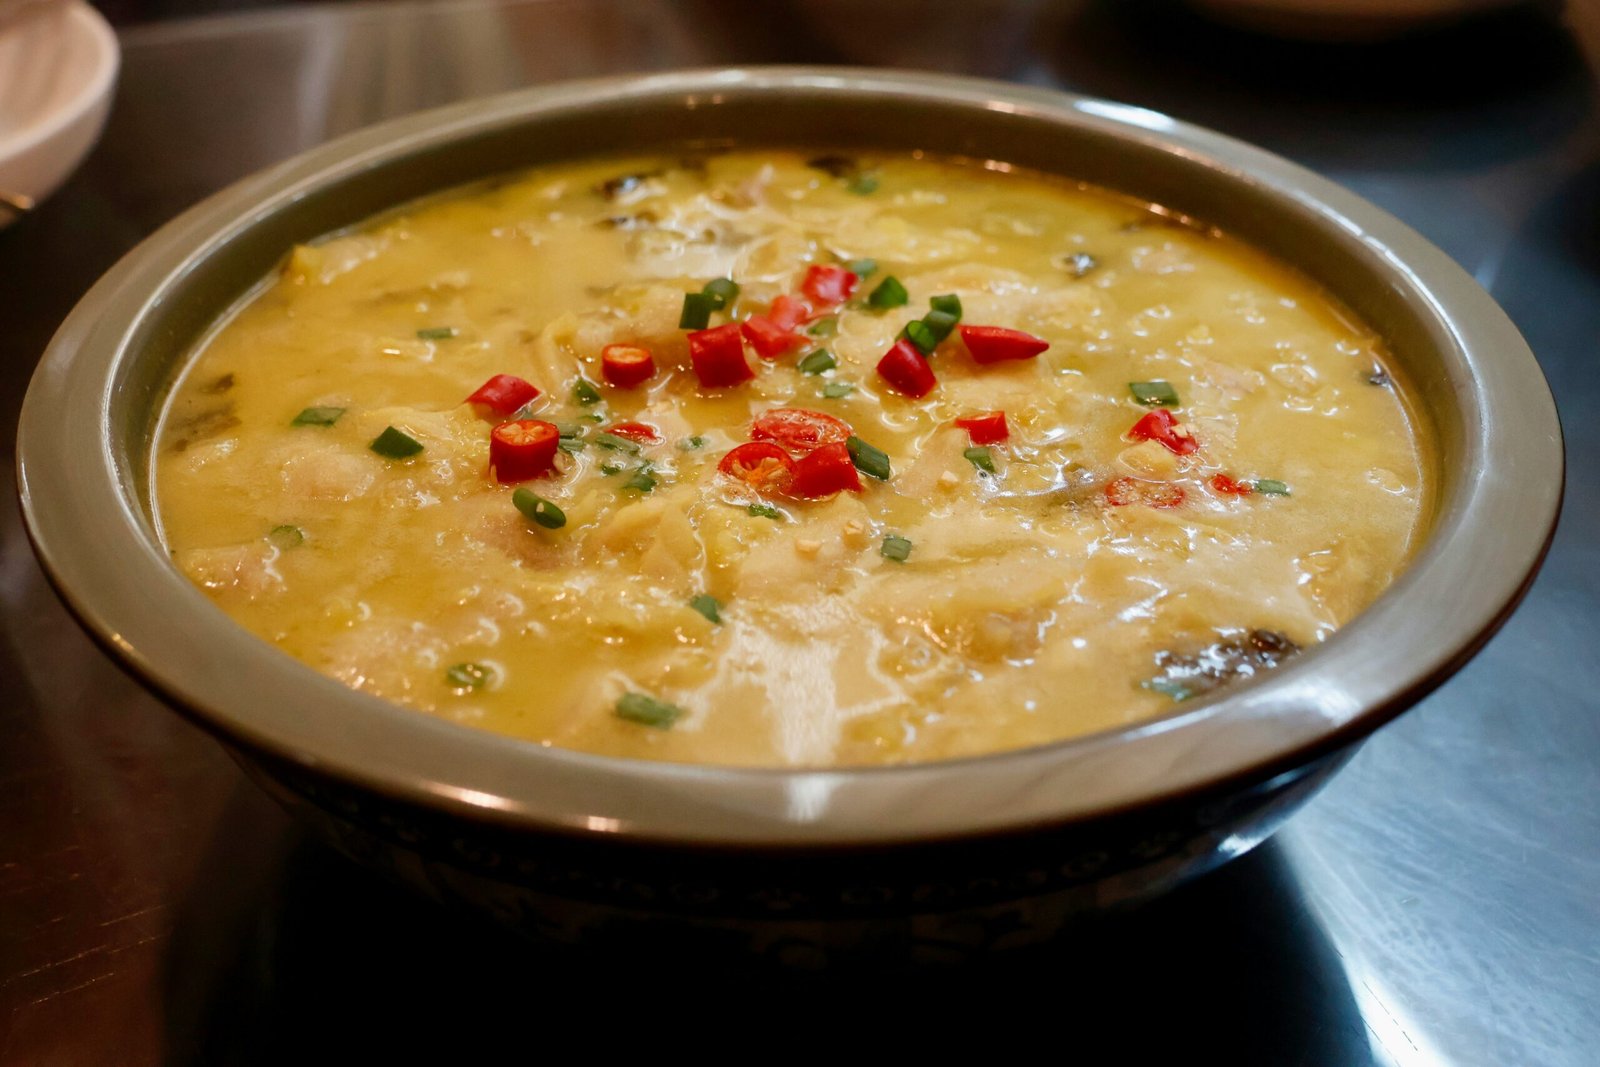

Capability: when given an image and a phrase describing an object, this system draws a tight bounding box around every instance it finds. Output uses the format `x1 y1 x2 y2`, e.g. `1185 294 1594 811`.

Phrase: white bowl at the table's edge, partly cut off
0 0 118 226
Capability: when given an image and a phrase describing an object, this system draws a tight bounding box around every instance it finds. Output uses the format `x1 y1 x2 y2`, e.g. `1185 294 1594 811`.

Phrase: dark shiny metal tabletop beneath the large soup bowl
0 0 1600 1065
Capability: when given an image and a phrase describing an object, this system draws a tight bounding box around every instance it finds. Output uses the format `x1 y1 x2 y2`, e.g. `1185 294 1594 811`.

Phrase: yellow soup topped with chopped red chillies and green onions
155 152 1429 766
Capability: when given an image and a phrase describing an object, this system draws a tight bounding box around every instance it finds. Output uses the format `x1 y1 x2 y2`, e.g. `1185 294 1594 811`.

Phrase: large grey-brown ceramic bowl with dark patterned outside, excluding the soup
18 69 1562 960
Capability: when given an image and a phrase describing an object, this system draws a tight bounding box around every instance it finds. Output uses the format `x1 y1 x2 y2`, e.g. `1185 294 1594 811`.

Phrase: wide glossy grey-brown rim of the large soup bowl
18 67 1565 848
